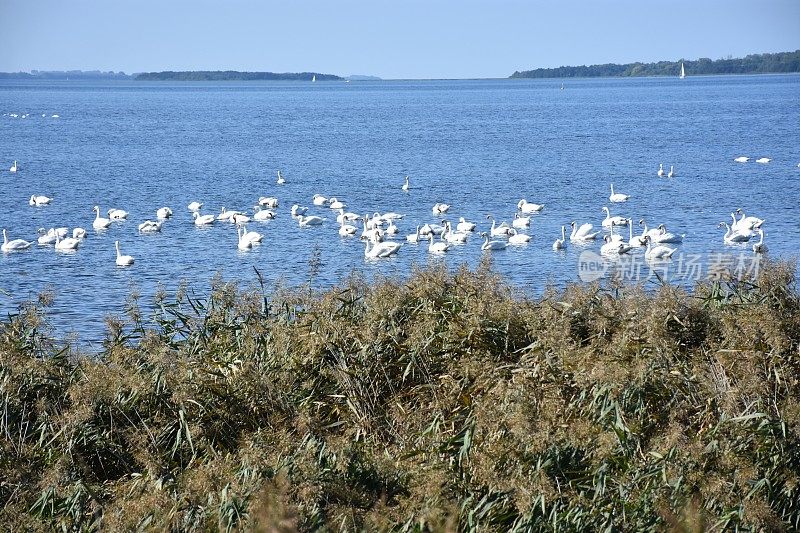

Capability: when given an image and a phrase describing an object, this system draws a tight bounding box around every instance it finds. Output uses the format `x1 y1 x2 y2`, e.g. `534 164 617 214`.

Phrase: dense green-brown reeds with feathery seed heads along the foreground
0 263 800 531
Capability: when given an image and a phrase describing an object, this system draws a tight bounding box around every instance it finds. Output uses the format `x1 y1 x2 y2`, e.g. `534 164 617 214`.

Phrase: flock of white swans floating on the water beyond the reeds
0 161 767 267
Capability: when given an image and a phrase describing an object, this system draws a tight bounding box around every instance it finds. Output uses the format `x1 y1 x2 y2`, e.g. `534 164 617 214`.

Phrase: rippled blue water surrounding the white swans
0 76 800 344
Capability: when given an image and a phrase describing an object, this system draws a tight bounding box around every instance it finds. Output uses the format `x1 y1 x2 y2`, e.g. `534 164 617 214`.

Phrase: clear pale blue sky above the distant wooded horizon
0 0 800 78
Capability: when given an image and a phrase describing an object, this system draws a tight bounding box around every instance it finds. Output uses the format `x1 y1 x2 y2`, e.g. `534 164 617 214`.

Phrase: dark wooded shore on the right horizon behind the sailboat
510 50 800 78
